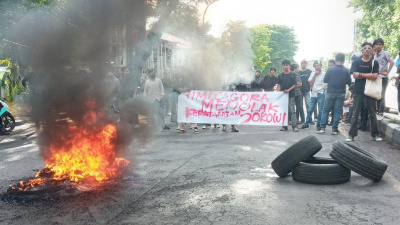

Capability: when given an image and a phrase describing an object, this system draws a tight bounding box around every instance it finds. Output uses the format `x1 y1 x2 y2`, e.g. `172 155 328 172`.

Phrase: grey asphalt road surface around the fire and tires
0 118 400 224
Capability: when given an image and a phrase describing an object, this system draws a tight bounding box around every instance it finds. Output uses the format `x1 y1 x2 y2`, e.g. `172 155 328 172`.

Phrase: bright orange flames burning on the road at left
11 101 129 191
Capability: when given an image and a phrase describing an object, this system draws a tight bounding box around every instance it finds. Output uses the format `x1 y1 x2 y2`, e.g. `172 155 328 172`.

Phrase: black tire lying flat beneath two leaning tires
292 157 351 184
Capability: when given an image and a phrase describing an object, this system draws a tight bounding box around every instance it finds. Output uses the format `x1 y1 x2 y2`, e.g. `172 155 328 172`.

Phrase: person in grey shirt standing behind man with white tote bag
373 38 394 116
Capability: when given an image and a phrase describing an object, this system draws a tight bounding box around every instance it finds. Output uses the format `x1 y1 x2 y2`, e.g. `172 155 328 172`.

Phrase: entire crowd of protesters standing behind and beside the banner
77 38 400 141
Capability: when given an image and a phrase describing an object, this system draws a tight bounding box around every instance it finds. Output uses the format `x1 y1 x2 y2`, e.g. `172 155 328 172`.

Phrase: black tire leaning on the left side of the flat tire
271 135 322 177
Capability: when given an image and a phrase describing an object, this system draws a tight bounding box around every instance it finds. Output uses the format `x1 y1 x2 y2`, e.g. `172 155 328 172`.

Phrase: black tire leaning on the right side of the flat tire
329 141 388 182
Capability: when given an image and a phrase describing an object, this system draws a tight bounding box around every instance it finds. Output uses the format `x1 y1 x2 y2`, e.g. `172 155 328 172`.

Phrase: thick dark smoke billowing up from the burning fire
7 0 156 163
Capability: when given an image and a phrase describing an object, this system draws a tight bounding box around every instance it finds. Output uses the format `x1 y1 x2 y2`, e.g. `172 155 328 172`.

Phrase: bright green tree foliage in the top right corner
349 0 400 55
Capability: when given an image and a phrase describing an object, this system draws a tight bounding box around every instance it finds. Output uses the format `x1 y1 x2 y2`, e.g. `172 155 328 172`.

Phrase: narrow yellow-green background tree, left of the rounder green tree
250 25 272 74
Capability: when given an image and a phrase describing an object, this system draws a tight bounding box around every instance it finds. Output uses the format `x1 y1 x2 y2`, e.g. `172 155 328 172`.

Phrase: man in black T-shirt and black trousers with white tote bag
346 42 382 141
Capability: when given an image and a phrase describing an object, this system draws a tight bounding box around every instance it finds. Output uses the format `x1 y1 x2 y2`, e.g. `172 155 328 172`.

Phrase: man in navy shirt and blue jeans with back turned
318 53 351 135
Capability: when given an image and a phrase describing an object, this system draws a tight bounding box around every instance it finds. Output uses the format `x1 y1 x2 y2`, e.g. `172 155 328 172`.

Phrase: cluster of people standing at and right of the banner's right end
251 38 400 142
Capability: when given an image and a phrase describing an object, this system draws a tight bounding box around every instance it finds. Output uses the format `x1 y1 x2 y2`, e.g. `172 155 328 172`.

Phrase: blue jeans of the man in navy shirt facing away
321 93 346 130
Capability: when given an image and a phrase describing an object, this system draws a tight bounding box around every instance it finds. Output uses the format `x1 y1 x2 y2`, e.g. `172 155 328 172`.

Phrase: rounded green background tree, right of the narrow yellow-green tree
264 25 298 73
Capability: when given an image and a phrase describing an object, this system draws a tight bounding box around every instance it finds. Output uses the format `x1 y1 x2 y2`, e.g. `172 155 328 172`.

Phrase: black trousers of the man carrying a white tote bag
349 93 379 137
